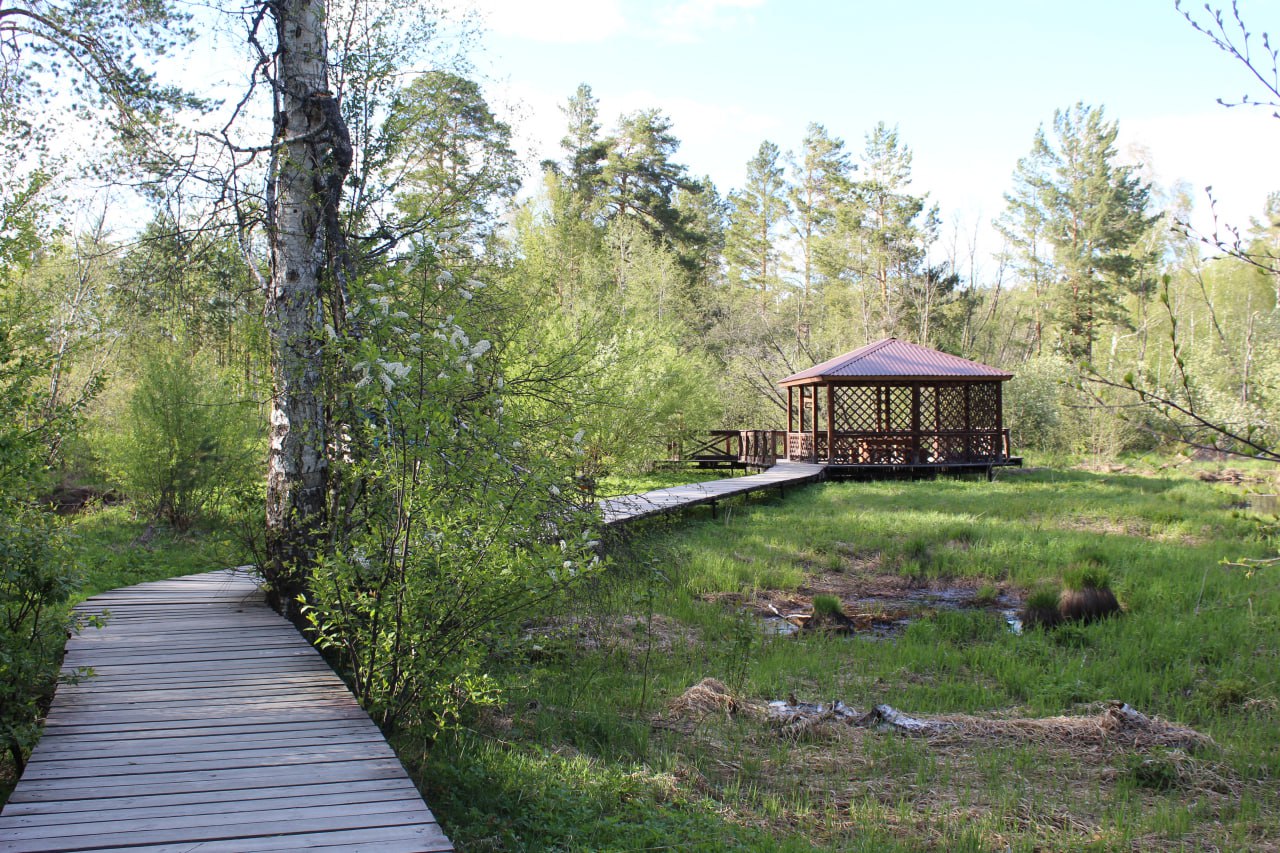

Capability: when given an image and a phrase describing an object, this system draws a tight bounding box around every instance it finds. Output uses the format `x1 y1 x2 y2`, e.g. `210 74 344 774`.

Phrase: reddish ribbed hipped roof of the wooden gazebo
778 338 1014 387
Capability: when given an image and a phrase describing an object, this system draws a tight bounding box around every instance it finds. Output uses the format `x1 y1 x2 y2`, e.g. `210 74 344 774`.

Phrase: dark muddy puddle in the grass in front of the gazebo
748 587 1023 639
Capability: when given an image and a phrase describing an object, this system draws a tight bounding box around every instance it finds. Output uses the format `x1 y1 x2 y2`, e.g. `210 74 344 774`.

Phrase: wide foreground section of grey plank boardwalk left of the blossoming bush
0 570 453 853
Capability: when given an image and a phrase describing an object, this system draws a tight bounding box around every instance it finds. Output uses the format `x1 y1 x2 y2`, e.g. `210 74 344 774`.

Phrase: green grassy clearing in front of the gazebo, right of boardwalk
419 470 1280 850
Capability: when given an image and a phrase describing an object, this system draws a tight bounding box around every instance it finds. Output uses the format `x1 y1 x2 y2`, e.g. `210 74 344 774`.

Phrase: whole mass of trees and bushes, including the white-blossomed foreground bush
0 3 1280 763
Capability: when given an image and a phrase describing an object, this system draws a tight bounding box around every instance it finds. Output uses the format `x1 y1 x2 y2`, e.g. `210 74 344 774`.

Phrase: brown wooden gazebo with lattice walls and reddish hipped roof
780 338 1021 473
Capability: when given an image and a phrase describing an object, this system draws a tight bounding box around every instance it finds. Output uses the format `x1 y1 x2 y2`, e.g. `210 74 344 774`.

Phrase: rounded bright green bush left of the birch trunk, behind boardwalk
101 346 261 529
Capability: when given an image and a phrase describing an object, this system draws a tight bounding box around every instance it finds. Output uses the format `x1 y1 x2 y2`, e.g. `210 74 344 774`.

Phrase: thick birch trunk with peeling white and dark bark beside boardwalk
264 0 352 612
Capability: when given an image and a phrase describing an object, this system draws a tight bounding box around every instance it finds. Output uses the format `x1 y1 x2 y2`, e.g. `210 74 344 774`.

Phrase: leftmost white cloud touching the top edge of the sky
470 0 627 44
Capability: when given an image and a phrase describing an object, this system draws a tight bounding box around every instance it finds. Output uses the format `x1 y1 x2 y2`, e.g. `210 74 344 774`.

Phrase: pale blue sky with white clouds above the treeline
466 0 1280 262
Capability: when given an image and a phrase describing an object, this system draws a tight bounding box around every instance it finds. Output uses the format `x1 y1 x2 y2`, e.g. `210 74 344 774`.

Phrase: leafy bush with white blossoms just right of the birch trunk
300 268 596 736
